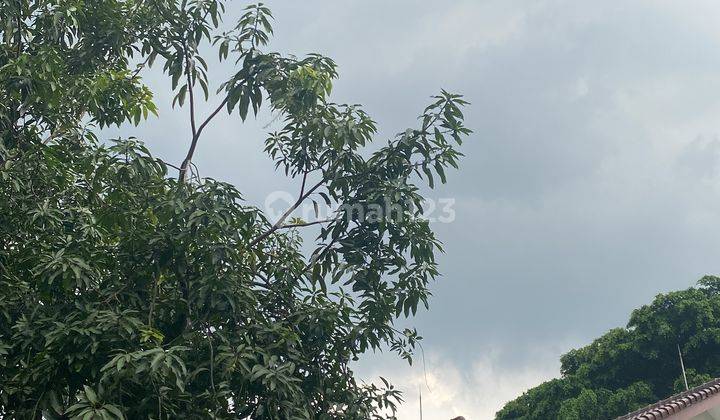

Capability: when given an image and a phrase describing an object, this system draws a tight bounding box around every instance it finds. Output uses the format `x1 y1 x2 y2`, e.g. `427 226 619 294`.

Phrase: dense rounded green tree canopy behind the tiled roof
497 276 720 420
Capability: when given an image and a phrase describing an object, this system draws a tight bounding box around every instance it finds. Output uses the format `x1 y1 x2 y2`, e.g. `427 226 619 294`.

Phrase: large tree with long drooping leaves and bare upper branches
0 0 470 419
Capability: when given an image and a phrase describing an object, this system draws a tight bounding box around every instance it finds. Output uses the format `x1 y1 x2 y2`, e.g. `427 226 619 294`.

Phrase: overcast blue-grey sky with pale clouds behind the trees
108 0 720 420
